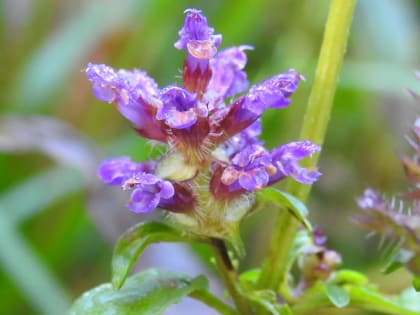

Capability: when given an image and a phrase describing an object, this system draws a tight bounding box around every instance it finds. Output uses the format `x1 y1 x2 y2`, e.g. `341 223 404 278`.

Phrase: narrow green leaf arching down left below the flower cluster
112 222 203 289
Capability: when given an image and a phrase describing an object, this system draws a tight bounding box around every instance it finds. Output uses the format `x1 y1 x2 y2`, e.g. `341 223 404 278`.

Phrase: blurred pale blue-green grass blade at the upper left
12 0 142 112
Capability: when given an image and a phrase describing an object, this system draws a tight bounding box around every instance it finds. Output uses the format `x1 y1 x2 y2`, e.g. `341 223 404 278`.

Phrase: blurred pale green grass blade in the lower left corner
0 208 70 315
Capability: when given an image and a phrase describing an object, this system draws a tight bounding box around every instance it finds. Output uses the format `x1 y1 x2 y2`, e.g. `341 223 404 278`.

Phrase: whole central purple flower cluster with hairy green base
86 9 320 233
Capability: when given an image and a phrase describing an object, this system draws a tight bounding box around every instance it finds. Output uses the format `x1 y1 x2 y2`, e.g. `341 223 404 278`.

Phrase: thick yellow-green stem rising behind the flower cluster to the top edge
259 0 356 298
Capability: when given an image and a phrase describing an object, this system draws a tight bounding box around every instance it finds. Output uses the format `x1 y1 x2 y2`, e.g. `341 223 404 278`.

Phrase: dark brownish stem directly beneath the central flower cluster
211 238 253 315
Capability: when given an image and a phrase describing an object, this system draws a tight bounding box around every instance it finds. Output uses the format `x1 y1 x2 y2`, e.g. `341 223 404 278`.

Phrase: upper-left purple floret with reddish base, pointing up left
85 63 167 141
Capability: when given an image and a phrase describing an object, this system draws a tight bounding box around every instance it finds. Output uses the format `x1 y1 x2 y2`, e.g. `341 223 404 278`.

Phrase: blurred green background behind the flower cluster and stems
0 0 420 314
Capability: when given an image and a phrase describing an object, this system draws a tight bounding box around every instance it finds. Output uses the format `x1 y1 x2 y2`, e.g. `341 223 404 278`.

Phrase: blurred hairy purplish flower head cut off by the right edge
353 82 420 276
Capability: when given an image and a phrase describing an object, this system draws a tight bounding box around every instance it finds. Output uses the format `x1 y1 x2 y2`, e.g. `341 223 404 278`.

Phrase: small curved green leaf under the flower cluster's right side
256 187 312 231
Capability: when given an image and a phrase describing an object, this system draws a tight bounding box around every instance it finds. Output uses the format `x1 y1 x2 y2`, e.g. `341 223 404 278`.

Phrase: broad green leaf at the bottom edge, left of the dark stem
67 269 208 315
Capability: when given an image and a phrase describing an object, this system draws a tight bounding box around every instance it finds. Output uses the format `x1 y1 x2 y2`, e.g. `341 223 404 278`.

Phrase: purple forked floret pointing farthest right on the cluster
270 141 321 184
